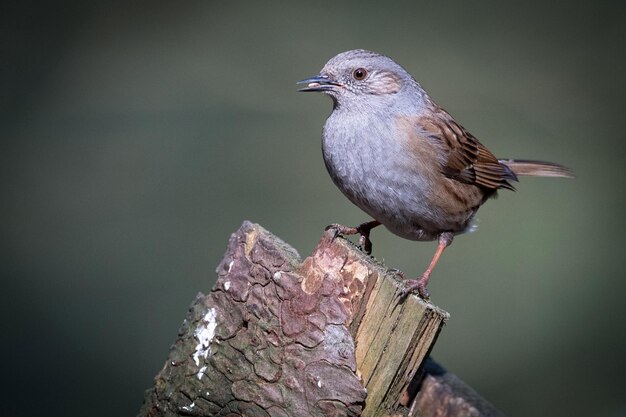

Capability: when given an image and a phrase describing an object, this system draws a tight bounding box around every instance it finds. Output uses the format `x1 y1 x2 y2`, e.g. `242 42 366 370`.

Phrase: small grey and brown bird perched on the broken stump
297 49 574 300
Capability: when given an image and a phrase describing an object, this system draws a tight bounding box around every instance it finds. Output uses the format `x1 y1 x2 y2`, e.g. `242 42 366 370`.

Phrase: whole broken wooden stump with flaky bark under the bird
139 222 501 417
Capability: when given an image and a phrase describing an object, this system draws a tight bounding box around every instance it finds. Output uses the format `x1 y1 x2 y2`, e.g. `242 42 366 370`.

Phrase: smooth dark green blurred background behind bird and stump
0 1 626 416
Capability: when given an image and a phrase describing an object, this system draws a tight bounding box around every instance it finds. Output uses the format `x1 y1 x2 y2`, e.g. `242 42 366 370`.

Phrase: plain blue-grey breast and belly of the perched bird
322 111 435 240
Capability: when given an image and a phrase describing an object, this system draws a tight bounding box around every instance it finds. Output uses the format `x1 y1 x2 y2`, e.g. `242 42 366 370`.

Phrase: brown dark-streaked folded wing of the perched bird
420 108 517 190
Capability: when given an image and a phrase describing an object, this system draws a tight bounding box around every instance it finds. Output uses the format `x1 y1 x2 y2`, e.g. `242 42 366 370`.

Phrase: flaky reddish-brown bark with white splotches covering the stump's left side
140 222 366 416
